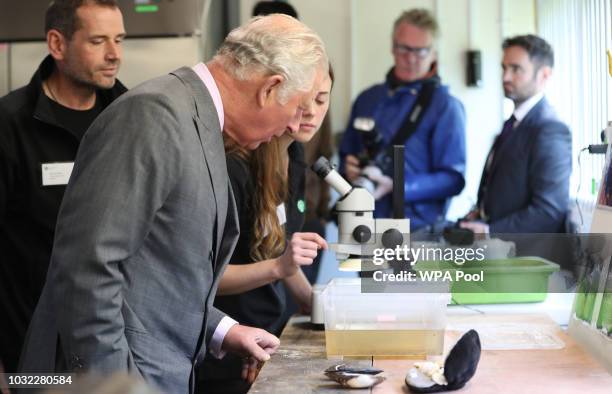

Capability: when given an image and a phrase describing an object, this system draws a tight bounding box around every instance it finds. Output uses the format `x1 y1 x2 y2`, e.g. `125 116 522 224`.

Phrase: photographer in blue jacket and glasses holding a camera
340 9 465 231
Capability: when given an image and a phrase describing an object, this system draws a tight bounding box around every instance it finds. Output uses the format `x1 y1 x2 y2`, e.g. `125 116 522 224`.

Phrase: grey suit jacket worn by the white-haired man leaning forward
21 68 239 393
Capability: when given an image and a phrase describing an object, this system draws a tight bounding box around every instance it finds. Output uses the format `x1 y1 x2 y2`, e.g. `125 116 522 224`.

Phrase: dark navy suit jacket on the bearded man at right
479 98 572 233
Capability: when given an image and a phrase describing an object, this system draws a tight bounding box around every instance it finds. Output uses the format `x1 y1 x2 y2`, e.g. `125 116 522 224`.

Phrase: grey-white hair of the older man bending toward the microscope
215 14 329 104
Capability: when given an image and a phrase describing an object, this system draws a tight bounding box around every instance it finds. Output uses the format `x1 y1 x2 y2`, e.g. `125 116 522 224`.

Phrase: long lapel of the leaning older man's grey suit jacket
172 67 229 268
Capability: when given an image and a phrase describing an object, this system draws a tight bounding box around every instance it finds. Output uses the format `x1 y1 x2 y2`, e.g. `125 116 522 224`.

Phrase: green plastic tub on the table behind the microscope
414 257 559 305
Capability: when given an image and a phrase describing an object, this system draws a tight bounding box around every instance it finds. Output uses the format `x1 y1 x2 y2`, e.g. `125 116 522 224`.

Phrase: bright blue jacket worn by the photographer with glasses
340 76 465 230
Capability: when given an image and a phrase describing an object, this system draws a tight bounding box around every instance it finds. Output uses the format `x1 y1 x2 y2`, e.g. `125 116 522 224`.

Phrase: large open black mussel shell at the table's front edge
406 330 481 393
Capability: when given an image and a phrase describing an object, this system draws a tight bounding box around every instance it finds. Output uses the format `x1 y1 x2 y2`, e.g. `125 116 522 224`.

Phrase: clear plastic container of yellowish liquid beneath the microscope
323 278 450 356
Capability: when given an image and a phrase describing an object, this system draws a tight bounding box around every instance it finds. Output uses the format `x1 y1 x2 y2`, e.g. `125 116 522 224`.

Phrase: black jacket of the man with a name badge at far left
0 56 127 372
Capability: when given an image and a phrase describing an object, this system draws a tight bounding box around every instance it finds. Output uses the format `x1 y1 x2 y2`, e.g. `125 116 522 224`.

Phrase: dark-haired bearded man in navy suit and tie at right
461 35 572 233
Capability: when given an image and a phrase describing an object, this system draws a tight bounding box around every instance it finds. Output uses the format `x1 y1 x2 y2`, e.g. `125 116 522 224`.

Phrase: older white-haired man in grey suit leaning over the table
21 15 328 393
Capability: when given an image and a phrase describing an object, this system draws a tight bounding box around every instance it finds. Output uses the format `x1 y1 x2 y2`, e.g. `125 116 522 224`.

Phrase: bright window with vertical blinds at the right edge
537 0 612 231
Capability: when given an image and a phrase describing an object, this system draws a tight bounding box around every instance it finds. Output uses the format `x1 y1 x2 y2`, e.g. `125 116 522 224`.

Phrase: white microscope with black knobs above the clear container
312 145 410 272
